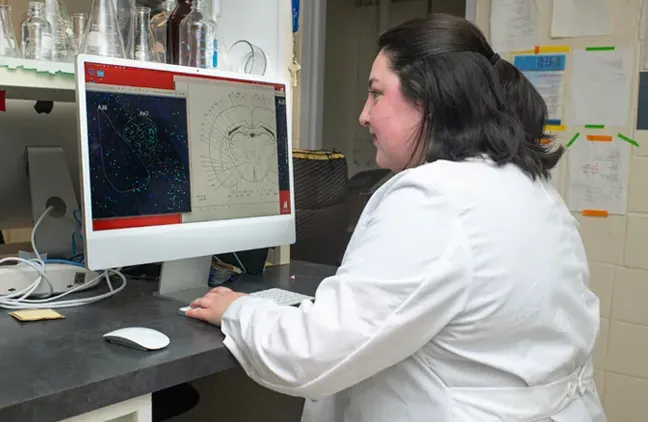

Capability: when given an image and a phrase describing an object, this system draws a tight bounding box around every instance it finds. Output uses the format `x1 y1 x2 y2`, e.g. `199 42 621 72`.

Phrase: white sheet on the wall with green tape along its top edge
567 47 634 127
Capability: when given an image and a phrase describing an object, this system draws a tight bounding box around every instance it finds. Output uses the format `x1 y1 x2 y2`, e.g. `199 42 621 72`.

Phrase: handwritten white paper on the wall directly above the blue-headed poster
490 0 539 53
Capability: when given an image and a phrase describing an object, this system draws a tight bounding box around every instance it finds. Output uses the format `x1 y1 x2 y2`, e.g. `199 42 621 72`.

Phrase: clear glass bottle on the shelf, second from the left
22 1 52 61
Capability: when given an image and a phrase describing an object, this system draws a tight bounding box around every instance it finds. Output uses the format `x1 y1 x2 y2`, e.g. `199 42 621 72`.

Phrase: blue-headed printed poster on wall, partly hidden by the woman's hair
513 54 567 126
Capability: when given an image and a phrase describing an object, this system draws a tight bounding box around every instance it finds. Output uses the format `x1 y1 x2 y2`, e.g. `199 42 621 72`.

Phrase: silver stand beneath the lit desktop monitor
156 256 212 304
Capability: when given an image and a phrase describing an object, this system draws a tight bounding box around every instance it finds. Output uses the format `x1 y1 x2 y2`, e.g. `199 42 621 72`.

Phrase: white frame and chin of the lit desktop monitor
76 55 296 287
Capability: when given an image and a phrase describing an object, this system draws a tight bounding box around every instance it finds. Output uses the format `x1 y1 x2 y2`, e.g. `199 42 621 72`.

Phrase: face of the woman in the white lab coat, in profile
359 52 422 171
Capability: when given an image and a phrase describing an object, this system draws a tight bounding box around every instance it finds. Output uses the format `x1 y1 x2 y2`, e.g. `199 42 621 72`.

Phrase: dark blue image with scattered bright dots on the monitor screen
86 91 191 219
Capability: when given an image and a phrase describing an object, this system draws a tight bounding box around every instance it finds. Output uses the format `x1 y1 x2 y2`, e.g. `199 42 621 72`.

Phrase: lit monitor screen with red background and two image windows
84 62 291 231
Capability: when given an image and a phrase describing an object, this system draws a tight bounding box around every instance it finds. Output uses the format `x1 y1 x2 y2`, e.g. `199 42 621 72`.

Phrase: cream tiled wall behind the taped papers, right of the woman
477 0 648 422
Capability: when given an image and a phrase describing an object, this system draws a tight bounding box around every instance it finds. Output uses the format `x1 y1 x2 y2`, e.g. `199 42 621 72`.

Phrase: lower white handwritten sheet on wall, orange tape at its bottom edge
567 136 630 214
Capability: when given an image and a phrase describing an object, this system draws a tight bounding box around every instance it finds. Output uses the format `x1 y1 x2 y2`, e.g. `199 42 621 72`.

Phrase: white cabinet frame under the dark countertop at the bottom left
60 394 153 422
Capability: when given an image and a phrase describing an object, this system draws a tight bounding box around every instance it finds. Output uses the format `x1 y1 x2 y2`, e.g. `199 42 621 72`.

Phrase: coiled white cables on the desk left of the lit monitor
0 207 126 309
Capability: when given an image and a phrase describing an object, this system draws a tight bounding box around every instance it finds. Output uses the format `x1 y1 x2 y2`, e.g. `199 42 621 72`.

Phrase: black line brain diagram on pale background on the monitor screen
184 77 279 210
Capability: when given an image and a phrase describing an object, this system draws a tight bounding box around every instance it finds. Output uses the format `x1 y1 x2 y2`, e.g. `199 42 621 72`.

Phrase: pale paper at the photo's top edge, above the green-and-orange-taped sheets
551 0 612 38
